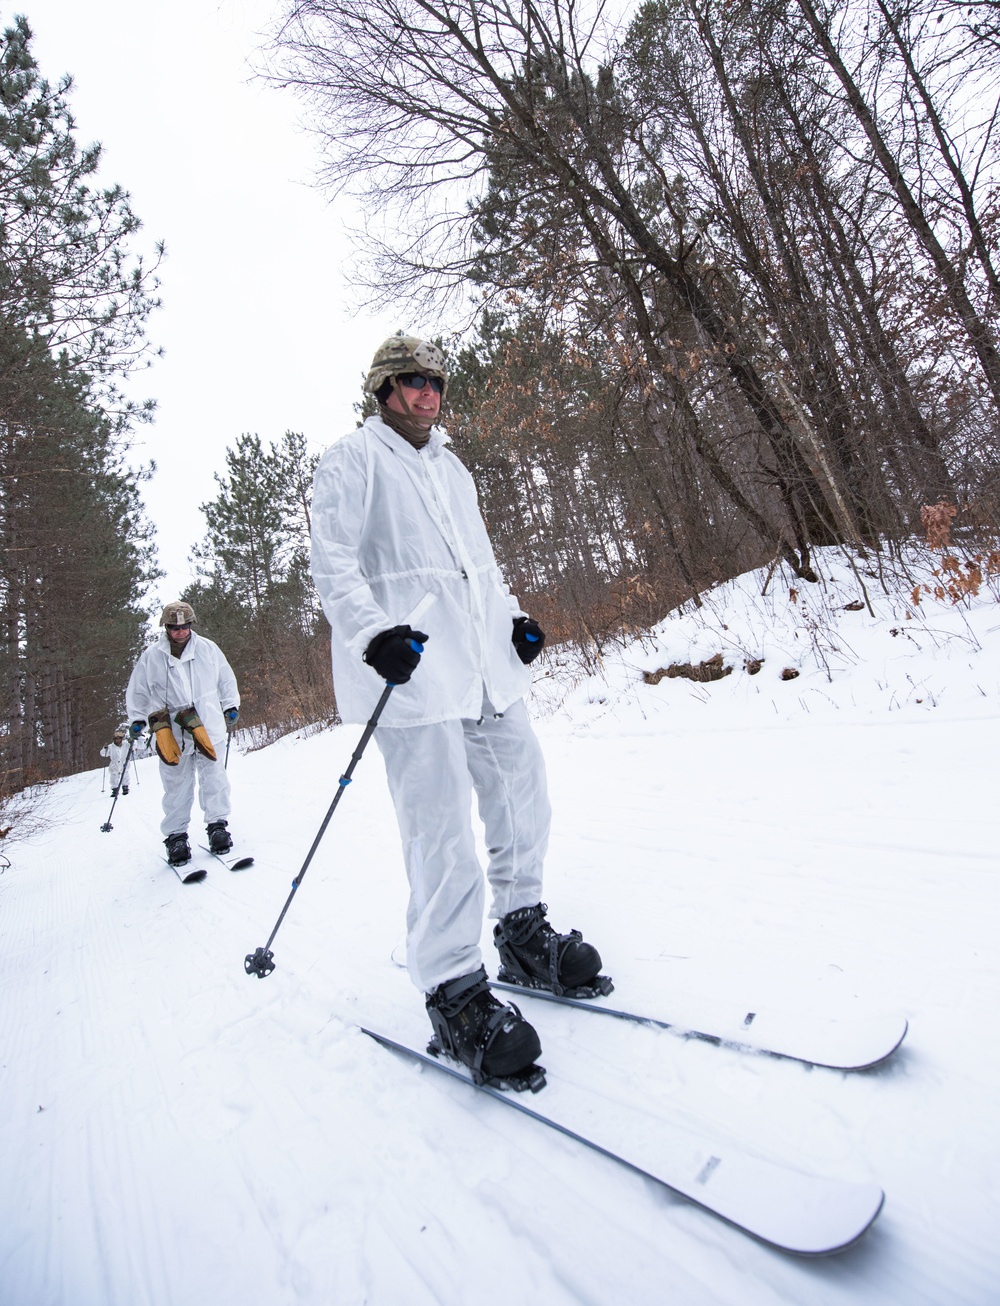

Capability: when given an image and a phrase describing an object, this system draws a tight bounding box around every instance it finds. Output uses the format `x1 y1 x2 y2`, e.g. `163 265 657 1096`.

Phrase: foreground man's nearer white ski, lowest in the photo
363 1029 885 1256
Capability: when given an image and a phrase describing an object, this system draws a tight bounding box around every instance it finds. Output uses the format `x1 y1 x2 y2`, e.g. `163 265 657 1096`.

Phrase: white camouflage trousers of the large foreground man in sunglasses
375 700 551 993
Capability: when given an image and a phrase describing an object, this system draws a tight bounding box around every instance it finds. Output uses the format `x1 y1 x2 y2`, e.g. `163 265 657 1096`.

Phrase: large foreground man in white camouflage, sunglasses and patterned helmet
312 336 611 1083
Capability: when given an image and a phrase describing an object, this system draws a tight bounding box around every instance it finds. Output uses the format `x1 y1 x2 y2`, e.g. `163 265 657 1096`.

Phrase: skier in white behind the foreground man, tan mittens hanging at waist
125 602 240 866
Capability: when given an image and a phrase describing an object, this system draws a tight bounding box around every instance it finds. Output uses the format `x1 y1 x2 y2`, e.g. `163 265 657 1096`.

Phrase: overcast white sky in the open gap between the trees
21 0 412 606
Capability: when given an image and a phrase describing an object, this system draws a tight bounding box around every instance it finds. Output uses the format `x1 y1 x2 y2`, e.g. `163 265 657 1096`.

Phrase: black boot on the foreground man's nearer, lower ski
426 966 546 1093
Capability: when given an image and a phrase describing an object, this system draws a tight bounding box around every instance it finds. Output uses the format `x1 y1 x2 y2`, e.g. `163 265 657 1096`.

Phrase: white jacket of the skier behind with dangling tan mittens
125 631 240 752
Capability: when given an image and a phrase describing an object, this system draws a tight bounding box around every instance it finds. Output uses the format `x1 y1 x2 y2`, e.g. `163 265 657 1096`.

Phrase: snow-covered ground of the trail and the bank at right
0 545 1000 1306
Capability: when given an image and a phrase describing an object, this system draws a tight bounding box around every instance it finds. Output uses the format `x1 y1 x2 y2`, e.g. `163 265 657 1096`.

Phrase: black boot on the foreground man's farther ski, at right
493 902 615 998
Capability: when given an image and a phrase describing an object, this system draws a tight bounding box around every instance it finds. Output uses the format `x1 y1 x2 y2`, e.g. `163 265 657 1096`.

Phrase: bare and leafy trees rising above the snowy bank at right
272 0 1000 643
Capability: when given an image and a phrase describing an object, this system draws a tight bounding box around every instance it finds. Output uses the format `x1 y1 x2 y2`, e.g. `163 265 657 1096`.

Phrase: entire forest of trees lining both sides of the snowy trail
0 0 1000 820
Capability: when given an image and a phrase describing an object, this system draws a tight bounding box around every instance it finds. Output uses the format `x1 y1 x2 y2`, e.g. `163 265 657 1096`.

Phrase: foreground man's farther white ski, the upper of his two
490 980 907 1070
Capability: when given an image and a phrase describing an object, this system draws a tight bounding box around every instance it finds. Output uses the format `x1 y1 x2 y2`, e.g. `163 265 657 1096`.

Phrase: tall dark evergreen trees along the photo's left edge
0 17 157 804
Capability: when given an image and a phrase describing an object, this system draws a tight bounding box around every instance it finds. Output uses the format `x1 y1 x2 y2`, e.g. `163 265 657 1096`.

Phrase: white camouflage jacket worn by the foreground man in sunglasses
312 417 531 726
